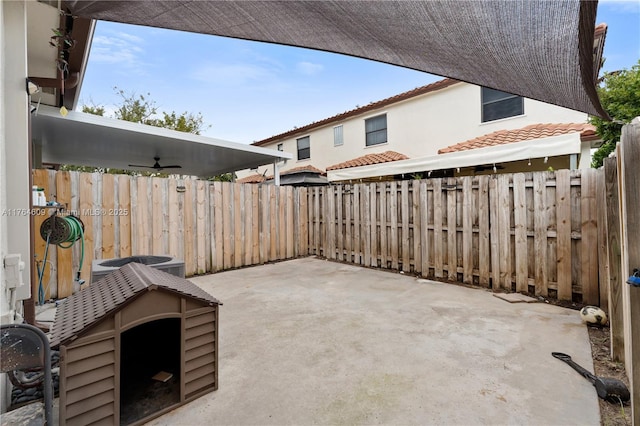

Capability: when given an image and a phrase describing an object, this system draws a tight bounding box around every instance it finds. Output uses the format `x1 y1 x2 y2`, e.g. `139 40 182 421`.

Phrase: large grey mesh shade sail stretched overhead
64 0 607 117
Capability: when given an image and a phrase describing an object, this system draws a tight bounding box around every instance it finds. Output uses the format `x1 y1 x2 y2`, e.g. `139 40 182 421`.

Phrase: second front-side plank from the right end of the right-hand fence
556 170 572 300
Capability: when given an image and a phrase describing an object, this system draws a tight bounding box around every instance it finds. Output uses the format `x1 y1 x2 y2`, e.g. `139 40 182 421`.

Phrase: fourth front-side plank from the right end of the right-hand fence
513 173 529 292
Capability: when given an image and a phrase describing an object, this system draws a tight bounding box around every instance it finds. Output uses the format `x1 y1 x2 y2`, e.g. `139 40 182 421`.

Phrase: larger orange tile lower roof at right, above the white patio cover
438 123 596 154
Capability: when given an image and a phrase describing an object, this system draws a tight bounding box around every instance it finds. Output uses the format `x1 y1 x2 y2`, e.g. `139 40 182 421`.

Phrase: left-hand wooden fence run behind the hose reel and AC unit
33 170 307 299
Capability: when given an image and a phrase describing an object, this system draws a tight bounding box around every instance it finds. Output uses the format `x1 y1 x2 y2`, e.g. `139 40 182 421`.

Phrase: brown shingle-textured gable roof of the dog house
51 263 222 346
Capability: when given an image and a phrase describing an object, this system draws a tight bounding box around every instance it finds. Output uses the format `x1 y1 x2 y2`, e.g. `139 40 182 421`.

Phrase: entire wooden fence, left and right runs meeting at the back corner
34 170 607 306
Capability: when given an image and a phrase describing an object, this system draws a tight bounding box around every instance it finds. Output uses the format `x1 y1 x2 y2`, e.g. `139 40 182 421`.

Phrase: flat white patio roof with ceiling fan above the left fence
32 105 292 176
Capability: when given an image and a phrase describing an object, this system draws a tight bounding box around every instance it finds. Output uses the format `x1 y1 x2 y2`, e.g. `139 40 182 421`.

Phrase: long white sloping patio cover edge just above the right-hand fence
327 132 582 182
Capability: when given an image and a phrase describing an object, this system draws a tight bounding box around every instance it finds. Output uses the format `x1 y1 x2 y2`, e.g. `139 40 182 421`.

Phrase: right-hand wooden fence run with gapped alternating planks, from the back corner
308 170 606 306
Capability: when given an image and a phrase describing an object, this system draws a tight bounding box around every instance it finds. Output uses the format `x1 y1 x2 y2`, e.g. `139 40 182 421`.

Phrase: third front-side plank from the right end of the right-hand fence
533 173 548 297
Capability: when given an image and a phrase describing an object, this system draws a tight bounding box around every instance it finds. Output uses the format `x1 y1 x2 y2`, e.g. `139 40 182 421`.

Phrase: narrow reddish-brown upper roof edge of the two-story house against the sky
251 78 460 146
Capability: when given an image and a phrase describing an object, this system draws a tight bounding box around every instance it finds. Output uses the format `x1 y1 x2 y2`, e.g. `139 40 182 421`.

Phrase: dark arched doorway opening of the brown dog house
120 318 181 425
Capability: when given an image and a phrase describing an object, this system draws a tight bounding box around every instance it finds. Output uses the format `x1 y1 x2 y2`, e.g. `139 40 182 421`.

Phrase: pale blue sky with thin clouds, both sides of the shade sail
80 0 640 143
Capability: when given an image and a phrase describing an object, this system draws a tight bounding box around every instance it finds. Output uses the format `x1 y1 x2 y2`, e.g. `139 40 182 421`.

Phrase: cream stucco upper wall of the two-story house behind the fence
238 83 587 177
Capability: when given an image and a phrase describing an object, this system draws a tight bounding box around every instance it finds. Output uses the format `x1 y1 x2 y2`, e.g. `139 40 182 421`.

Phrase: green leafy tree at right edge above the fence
589 60 640 168
